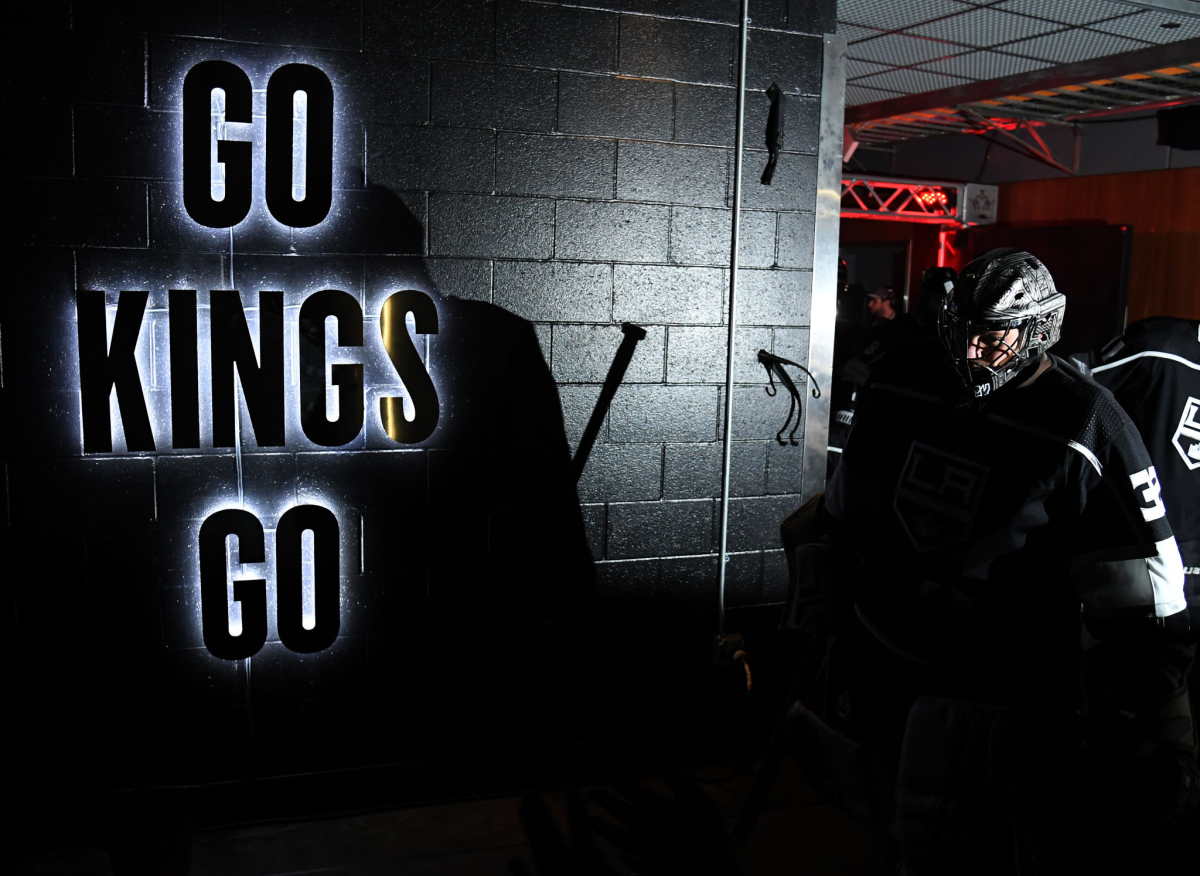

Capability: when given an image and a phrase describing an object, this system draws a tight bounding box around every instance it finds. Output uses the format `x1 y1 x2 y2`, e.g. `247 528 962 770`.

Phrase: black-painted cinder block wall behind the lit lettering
0 0 835 799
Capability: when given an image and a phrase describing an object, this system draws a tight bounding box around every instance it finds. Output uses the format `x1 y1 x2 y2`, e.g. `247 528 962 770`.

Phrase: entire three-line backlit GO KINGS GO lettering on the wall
77 60 439 660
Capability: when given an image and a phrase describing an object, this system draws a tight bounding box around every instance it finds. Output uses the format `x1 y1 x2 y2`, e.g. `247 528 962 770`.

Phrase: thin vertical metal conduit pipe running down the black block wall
716 0 750 641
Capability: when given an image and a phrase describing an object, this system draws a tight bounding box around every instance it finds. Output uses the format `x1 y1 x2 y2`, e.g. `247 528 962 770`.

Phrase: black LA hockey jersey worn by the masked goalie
826 341 1186 664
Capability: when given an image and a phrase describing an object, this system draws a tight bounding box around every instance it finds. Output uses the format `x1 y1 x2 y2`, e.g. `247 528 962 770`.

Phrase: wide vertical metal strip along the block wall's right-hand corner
800 34 846 502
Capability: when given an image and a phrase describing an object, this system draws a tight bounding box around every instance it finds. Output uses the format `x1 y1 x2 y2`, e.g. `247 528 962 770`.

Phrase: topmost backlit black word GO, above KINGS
184 61 334 228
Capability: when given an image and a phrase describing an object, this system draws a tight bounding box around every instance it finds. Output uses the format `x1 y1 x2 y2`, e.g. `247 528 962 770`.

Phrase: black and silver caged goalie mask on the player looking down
937 248 1067 401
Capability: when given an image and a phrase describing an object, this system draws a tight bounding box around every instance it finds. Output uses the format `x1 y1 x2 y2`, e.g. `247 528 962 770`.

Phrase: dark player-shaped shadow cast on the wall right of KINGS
338 186 594 622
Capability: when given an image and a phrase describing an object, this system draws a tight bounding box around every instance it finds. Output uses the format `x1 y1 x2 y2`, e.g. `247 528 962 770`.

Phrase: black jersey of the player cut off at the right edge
1092 317 1200 626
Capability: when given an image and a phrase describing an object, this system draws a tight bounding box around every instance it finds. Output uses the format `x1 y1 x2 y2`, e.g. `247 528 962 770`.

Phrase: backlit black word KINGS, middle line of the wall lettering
76 289 440 454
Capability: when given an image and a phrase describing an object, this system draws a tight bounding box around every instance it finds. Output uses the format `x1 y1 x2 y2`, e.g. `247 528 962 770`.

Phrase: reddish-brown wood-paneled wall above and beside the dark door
998 168 1200 323
